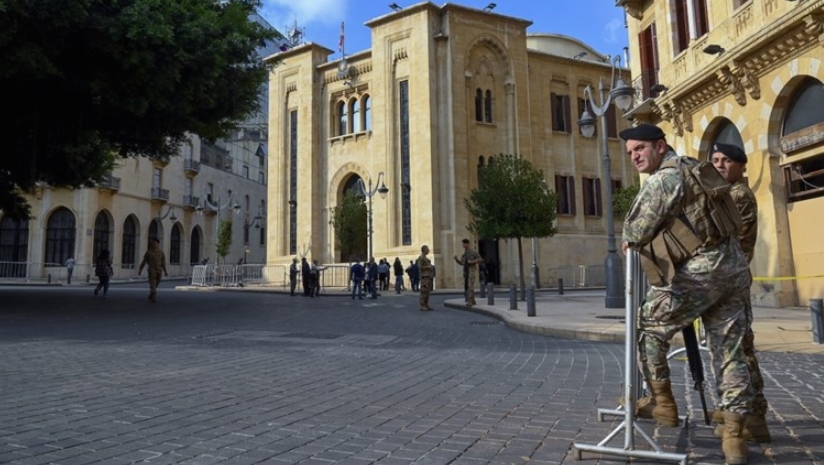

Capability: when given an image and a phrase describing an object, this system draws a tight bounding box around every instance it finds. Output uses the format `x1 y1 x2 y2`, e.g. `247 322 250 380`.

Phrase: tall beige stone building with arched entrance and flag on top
267 2 636 287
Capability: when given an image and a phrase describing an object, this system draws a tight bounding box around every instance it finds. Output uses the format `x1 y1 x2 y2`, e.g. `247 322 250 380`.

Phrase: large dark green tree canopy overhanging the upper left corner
0 0 280 218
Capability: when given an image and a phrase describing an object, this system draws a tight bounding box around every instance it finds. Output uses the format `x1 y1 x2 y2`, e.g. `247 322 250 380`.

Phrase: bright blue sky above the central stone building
261 0 628 58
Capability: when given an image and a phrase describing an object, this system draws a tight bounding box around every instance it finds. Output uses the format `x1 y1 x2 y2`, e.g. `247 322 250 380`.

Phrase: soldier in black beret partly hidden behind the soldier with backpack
711 143 772 442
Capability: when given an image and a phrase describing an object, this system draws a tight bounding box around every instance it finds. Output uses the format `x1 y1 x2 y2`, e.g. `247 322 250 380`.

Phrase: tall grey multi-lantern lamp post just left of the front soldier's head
578 55 635 308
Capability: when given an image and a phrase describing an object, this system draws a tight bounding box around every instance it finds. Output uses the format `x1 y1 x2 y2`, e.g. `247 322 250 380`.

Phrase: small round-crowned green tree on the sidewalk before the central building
464 155 557 296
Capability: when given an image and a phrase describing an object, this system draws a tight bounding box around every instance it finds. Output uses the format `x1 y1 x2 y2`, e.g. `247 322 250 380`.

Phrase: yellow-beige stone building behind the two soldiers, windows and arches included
617 0 824 306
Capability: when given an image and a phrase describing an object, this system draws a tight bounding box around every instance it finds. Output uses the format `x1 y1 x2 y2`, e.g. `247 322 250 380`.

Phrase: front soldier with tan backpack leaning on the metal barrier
620 124 754 464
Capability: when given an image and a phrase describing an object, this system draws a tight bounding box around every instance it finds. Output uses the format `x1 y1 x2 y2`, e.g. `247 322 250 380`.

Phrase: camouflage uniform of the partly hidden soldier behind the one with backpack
730 179 767 416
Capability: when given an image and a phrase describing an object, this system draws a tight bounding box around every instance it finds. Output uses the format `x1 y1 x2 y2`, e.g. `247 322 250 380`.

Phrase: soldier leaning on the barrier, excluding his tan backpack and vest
620 124 753 465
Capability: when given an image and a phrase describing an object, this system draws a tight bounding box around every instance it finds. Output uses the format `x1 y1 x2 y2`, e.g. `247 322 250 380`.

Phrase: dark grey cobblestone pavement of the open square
0 285 824 465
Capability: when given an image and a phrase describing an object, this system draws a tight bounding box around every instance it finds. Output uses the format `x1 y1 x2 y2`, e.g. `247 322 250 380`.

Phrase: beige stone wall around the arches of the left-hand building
9 133 266 278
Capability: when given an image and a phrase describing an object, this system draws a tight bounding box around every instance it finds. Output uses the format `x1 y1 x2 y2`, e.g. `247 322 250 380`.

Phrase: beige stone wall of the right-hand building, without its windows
622 0 824 306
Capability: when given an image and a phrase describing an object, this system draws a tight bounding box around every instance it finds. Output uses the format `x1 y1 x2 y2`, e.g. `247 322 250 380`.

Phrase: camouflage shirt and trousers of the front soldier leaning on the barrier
624 151 753 415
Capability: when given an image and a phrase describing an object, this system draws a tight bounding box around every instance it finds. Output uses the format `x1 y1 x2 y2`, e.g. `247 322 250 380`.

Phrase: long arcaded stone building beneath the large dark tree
0 131 267 280
